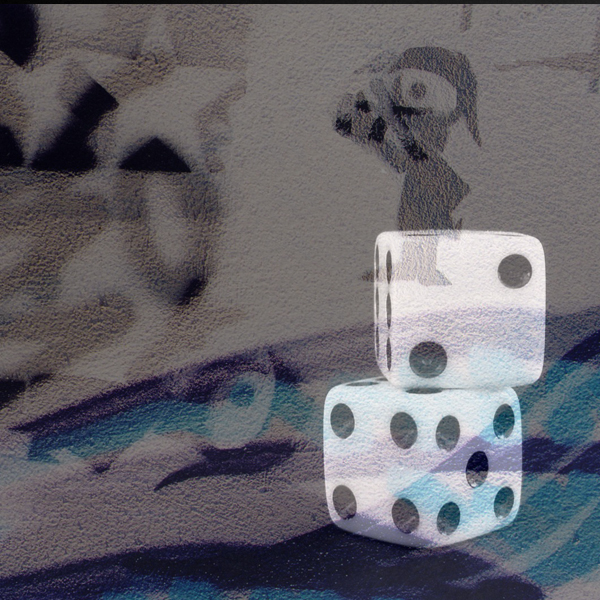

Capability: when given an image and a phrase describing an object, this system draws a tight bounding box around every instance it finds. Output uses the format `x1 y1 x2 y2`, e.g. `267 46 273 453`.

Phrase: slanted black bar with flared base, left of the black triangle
31 82 118 172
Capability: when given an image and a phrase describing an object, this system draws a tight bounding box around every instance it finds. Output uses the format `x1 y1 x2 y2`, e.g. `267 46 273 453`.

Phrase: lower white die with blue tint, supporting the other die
324 377 522 546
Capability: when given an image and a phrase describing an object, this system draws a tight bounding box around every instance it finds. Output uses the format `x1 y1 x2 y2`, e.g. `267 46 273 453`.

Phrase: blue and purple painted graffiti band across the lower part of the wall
0 313 600 599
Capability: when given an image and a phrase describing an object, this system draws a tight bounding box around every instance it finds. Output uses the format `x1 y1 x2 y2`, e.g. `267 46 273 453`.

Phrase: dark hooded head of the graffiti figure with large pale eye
375 46 481 150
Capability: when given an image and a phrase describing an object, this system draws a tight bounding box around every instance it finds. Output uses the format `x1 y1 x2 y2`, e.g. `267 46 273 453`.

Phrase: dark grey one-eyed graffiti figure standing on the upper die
335 47 481 285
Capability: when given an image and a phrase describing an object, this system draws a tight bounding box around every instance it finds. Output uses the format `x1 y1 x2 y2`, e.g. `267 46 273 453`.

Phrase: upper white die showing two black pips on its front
375 231 546 388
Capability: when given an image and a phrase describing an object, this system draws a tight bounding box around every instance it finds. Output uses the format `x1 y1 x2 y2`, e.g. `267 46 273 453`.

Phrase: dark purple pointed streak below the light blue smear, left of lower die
154 441 296 492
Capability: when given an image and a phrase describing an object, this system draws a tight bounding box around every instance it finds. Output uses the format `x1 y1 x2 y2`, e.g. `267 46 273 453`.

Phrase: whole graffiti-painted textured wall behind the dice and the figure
0 5 600 600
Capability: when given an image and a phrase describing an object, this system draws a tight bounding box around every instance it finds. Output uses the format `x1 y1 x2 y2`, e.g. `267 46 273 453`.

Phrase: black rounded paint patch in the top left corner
0 4 38 67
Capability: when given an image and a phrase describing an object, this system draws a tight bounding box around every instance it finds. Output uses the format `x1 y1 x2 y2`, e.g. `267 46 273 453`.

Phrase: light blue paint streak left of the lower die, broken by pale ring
29 383 322 462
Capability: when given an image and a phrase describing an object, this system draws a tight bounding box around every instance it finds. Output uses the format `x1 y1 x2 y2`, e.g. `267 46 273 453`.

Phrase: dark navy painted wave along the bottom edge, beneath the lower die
1 525 543 600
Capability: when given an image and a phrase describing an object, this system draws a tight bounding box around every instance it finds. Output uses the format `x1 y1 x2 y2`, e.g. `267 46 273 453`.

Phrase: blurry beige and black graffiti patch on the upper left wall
0 5 244 406
